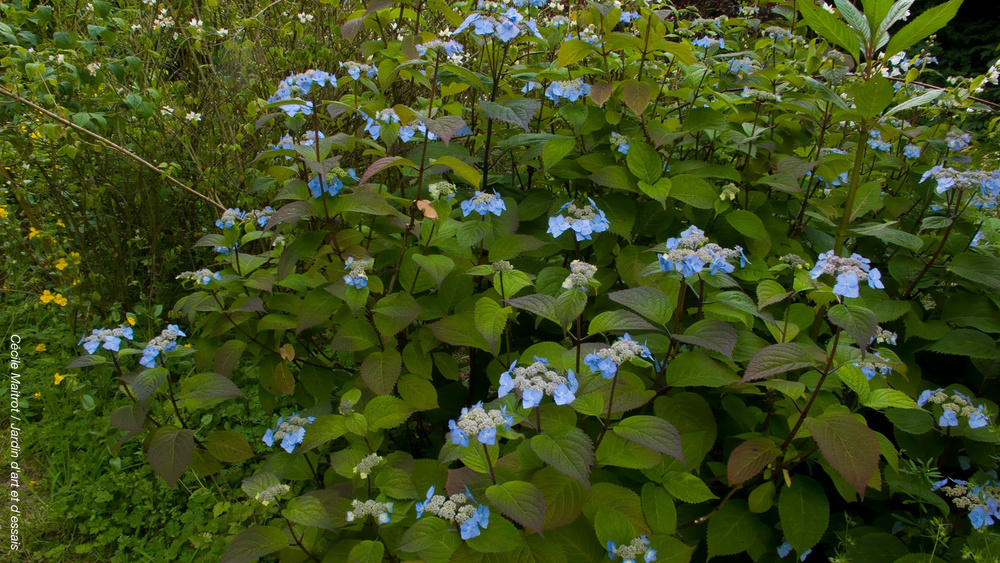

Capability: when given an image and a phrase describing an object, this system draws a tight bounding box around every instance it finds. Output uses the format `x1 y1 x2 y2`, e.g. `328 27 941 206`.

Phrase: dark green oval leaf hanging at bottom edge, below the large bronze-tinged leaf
778 475 830 555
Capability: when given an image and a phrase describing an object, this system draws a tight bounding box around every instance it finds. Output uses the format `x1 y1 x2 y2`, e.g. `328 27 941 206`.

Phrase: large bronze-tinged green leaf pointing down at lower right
805 412 879 500
